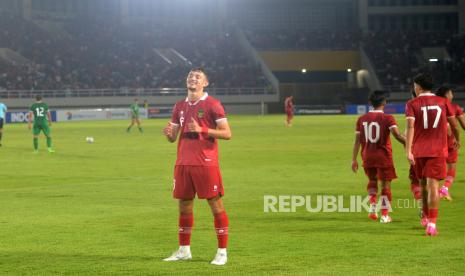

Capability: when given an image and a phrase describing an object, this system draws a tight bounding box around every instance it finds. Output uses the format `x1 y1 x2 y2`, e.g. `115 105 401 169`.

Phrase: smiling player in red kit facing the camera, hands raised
163 68 231 265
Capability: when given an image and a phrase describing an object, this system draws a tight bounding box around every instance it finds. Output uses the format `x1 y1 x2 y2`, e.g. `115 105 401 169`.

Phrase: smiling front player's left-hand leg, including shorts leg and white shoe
164 166 195 261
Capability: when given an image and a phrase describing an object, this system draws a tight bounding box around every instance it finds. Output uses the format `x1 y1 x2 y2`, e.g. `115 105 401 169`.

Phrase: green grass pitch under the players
0 116 465 275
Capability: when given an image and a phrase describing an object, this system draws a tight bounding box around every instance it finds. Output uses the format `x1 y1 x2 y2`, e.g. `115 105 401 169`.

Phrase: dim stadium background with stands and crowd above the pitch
0 0 465 114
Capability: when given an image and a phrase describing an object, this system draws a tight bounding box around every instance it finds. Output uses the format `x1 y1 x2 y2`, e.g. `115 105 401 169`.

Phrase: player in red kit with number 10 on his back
352 91 405 223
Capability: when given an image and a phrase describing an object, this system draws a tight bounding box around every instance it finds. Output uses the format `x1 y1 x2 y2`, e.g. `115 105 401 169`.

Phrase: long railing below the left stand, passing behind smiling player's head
0 87 275 99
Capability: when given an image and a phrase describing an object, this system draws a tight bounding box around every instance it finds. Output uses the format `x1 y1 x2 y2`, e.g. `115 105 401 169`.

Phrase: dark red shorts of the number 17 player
415 157 447 180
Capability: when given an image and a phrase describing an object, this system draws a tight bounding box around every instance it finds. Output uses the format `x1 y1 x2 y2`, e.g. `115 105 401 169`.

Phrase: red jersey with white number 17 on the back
405 93 455 158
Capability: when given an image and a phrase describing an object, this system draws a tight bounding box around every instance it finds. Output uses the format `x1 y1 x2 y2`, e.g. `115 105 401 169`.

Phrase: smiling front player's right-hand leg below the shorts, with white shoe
208 195 229 265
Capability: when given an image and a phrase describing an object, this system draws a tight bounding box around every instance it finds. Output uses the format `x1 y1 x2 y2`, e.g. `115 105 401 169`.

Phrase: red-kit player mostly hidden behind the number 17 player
436 86 465 200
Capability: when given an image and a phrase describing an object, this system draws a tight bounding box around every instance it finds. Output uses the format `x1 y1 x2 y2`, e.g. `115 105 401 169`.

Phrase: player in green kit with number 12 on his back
28 95 55 153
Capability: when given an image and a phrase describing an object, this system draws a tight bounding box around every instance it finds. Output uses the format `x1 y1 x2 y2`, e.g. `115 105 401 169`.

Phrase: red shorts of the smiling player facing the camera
173 166 224 199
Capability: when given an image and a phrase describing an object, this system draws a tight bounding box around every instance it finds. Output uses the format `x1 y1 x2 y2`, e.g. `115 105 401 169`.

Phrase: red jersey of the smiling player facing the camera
171 93 226 167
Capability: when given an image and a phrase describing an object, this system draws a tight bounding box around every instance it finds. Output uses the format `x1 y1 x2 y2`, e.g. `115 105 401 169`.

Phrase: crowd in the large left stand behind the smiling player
0 14 266 90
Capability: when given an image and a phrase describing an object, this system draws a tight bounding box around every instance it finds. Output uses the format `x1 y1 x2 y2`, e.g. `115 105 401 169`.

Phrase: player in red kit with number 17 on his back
405 74 460 236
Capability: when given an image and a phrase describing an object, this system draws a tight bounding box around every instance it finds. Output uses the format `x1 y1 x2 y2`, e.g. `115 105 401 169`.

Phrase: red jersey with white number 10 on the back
355 110 397 168
